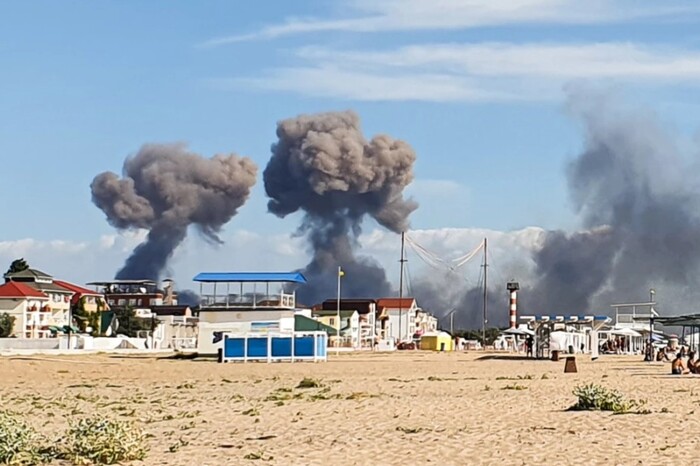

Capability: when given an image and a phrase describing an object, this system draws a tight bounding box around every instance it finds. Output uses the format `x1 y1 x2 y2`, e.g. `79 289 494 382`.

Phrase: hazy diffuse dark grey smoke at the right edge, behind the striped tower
523 87 700 312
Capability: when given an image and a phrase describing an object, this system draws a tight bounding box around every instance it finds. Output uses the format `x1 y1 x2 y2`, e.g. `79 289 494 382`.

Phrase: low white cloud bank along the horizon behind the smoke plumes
0 228 542 289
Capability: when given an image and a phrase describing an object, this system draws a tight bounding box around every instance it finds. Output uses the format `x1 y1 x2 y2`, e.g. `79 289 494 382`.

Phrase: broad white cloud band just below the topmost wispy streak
230 43 700 102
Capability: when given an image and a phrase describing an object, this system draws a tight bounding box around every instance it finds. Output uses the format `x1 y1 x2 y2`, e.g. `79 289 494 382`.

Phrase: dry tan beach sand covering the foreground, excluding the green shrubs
0 351 700 465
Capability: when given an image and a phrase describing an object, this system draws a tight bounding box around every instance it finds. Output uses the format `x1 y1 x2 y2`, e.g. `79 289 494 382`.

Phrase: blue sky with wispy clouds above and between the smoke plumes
0 0 700 288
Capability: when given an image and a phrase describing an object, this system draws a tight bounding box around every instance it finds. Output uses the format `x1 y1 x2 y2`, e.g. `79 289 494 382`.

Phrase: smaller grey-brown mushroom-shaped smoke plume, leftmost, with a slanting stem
90 144 257 280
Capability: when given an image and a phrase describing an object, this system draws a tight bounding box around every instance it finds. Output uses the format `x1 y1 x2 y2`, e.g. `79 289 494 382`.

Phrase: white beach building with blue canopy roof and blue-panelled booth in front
193 272 335 362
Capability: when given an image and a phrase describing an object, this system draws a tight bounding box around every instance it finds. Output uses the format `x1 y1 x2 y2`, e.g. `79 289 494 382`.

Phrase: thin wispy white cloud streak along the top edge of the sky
203 0 700 47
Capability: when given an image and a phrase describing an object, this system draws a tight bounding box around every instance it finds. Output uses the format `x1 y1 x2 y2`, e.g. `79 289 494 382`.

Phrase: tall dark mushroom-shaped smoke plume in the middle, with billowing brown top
263 111 418 304
